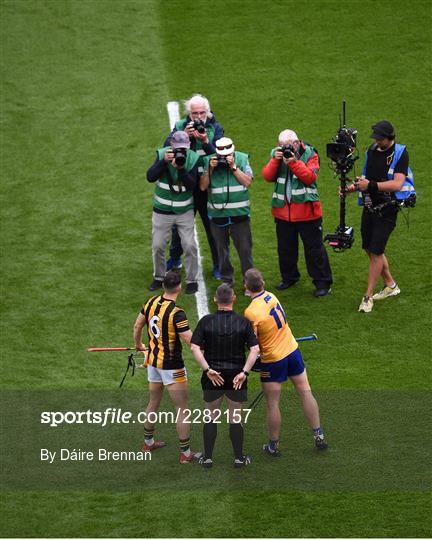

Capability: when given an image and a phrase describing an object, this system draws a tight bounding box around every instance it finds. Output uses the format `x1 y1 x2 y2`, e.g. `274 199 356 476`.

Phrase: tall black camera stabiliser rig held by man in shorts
324 100 358 252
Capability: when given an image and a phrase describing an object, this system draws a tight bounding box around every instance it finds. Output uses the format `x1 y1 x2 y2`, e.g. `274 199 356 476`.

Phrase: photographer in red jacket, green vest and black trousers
262 129 333 298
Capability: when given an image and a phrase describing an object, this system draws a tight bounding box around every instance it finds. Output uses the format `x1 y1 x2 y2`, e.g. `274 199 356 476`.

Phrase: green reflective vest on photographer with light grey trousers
153 147 199 214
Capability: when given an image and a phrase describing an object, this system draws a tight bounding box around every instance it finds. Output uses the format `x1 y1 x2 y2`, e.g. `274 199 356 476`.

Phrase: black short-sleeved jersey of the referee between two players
191 310 258 370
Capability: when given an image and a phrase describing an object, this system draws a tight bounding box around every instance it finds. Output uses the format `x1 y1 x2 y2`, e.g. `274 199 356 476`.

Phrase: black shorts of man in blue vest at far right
361 210 397 255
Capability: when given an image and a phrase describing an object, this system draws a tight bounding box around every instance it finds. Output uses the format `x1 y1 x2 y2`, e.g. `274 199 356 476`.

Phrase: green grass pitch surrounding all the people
0 0 431 537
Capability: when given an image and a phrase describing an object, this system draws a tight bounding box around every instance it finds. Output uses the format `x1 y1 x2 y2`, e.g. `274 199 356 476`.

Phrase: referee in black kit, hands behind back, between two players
191 283 259 468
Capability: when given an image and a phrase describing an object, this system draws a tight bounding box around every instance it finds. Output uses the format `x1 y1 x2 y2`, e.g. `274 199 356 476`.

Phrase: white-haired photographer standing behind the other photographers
165 94 223 279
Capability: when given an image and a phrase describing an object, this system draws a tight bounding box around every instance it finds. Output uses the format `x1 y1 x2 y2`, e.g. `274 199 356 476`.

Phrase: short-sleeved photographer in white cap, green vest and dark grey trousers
200 137 253 285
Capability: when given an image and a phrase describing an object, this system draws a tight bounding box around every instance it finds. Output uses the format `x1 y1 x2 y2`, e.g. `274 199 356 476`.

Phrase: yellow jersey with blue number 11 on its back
244 291 298 362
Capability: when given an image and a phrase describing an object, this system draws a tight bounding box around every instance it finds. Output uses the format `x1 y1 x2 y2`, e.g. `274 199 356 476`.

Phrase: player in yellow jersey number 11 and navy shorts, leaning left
244 268 327 457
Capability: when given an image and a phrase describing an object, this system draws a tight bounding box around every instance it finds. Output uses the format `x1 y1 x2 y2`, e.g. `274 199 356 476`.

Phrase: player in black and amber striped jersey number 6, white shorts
133 272 201 463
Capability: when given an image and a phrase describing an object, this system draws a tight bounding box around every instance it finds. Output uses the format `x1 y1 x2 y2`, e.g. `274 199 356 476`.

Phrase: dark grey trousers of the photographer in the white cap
210 219 253 283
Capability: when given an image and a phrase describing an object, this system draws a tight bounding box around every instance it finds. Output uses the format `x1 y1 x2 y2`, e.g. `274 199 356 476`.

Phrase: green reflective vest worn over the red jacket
271 144 319 208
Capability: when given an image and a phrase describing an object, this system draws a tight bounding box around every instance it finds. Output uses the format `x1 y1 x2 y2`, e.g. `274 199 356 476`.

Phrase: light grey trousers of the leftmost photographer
152 210 198 283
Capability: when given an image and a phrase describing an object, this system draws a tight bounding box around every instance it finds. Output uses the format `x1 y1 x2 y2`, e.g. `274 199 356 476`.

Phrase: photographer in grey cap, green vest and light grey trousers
147 131 199 294
